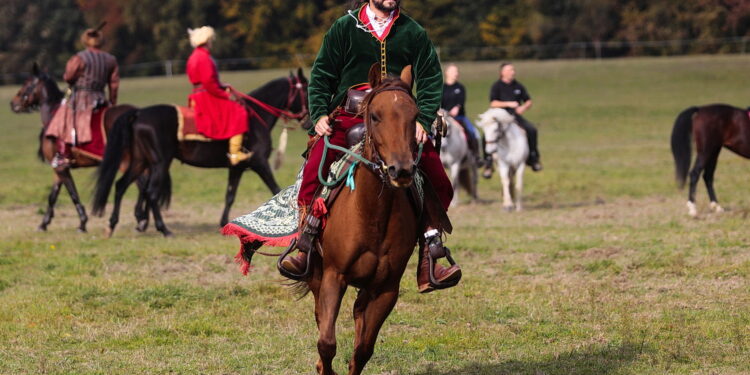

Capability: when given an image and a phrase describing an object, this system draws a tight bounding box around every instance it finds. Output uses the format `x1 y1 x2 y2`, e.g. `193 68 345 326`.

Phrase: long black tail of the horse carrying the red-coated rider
91 109 138 216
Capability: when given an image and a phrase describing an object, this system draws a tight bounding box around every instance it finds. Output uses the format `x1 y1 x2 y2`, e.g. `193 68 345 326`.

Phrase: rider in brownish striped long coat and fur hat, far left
45 26 120 168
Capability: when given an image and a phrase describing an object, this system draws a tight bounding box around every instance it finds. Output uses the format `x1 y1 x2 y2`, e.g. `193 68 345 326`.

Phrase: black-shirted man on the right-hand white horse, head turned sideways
485 63 542 175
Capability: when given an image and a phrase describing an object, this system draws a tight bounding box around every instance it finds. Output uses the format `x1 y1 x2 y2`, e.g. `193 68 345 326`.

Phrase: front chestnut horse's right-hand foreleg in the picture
349 281 398 375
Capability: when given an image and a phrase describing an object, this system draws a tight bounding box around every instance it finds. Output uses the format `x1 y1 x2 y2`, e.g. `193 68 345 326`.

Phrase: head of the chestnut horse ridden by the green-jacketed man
364 64 419 188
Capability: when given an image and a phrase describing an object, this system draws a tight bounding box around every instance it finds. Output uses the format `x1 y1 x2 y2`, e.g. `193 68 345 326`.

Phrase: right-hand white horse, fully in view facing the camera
479 108 529 211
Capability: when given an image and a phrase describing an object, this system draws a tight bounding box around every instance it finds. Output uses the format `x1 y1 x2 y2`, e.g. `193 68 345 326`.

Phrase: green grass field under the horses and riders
0 56 750 375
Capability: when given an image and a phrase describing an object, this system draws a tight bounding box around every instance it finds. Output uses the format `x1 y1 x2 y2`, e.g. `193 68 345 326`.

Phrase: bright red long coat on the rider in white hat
185 47 247 139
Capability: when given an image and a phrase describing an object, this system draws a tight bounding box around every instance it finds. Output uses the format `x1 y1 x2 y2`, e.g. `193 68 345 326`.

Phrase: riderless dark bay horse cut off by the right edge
672 104 750 216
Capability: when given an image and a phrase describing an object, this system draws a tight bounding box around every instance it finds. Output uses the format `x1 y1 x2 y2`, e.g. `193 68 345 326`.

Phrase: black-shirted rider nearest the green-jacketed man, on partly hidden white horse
440 64 481 163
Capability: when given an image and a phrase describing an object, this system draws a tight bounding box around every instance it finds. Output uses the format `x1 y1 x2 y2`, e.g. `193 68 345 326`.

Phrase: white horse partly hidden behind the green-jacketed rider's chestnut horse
438 109 478 206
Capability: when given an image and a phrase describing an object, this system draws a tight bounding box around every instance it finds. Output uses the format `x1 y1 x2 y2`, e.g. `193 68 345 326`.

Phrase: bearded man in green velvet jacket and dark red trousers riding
281 0 461 293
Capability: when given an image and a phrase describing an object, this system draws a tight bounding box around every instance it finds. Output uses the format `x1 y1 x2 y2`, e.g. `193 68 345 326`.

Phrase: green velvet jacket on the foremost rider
307 4 443 133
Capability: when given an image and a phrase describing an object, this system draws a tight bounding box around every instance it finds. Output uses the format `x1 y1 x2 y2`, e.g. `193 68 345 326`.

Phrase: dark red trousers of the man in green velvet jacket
297 115 453 211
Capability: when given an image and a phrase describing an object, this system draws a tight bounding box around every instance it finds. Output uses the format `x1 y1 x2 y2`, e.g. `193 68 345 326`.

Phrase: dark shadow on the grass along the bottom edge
414 343 647 375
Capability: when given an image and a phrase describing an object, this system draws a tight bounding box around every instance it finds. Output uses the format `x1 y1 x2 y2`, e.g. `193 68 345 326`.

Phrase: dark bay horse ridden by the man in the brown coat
10 63 139 232
